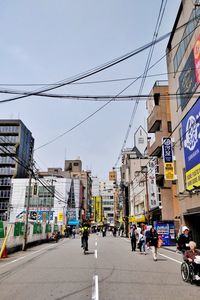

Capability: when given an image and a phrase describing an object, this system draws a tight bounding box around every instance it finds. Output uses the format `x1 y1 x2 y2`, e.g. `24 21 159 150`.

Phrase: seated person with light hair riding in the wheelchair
183 241 200 280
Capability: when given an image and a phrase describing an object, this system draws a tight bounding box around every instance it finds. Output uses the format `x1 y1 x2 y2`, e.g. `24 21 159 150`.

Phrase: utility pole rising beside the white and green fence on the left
22 154 33 251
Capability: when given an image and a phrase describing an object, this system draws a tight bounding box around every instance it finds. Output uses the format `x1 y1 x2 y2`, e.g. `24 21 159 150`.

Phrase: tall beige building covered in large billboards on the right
166 1 200 243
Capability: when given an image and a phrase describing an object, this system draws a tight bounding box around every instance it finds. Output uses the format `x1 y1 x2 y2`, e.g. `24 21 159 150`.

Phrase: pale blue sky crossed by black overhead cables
0 0 181 180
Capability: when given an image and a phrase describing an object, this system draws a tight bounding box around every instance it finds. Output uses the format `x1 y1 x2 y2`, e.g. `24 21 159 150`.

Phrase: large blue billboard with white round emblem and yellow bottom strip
182 98 200 190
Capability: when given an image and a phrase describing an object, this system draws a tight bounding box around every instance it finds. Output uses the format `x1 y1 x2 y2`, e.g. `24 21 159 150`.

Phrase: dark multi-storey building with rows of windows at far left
0 120 34 220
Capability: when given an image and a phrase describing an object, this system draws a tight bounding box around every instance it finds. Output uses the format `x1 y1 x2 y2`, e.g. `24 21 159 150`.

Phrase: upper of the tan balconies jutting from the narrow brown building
147 105 162 133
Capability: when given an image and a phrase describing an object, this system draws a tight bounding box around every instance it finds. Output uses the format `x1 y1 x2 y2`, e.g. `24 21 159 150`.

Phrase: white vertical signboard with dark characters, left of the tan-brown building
147 157 159 209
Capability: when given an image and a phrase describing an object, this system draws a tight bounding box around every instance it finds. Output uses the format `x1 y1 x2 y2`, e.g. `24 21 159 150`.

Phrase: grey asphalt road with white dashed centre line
0 234 200 300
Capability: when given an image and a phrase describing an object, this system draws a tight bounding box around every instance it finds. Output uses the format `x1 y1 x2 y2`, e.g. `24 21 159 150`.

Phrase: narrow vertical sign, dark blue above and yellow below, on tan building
162 137 174 180
